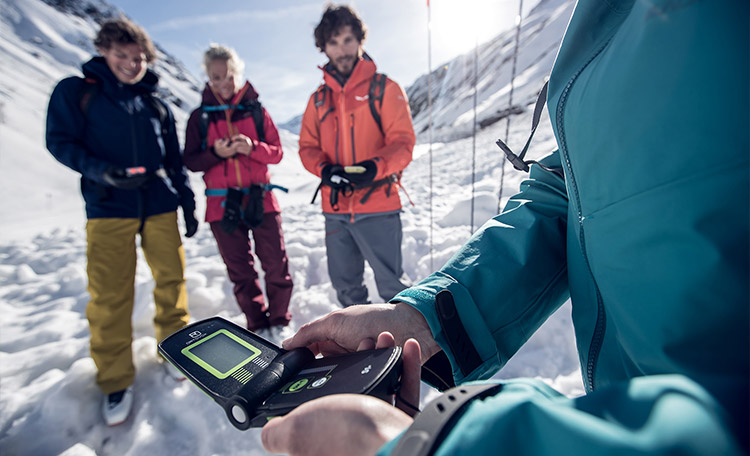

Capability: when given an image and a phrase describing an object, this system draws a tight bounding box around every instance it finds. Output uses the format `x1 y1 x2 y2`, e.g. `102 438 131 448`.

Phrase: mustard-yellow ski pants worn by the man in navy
86 212 190 394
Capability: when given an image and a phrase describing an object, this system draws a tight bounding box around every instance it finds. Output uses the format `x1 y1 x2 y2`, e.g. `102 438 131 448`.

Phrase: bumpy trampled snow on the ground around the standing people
0 121 582 455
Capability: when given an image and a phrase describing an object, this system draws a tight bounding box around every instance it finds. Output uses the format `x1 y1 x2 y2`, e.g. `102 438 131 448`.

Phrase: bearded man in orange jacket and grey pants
299 5 415 307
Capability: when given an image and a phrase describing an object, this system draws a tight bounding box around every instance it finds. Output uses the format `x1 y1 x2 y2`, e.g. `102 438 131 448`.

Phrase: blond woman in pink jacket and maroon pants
183 45 292 331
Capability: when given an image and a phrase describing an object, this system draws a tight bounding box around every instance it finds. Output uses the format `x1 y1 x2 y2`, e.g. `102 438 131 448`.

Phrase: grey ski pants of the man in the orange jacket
325 213 409 307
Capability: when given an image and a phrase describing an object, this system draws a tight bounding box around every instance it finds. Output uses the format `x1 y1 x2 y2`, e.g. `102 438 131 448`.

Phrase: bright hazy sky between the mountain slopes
109 0 538 123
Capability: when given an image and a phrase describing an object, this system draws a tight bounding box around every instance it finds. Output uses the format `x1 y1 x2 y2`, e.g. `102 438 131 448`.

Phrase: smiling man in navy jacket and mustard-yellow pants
47 19 198 425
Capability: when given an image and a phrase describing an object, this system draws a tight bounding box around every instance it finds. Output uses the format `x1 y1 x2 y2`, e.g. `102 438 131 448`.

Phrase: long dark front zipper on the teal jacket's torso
556 40 610 391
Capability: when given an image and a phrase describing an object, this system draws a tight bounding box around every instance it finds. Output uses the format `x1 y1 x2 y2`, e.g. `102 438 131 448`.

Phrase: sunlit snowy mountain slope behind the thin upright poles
406 0 575 142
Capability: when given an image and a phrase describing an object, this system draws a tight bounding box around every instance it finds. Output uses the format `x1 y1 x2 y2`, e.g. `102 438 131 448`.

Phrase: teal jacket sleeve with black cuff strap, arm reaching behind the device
394 153 569 384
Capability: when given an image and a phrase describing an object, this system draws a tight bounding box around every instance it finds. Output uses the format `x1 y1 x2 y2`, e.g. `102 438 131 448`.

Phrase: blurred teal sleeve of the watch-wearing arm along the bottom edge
378 375 743 456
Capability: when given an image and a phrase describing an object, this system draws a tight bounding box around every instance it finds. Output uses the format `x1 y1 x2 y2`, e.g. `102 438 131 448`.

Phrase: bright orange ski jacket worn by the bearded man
299 55 416 216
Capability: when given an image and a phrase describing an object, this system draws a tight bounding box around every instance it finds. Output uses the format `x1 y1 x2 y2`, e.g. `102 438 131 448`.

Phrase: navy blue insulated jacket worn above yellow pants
47 57 195 219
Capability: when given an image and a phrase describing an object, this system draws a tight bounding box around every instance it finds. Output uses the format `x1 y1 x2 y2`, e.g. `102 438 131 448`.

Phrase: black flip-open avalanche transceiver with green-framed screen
159 317 401 430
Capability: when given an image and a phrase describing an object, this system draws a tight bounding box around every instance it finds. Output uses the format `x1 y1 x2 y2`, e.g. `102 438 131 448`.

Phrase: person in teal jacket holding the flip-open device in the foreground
262 0 750 455
